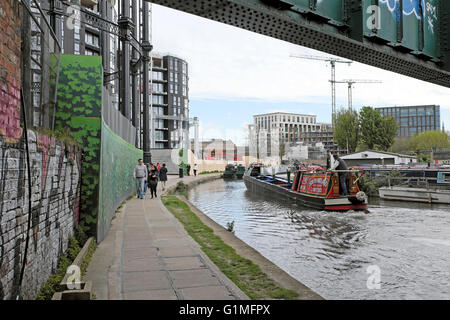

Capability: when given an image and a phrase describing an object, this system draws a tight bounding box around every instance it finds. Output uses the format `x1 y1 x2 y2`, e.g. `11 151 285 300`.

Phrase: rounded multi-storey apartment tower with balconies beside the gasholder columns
151 54 190 149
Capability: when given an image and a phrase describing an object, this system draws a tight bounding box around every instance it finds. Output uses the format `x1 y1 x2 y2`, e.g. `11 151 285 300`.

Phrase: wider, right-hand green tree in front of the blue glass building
359 107 398 151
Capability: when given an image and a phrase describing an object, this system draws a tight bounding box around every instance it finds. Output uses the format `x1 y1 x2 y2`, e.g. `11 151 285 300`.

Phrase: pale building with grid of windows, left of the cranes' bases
249 112 337 159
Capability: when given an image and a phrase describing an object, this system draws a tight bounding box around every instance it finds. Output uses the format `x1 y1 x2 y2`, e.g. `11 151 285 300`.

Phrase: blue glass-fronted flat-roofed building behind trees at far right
376 105 441 138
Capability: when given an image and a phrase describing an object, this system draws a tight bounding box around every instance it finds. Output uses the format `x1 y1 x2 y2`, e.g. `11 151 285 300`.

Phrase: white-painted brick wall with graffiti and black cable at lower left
0 131 81 300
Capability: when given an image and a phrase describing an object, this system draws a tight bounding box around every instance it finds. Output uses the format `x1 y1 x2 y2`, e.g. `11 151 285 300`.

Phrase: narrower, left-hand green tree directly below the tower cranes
334 109 359 153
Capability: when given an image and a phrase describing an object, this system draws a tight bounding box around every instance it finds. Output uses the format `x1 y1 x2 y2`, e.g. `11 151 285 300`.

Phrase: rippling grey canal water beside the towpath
188 179 450 299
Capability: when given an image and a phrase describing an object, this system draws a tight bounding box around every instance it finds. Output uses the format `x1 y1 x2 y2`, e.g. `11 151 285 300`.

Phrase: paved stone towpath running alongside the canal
85 176 248 300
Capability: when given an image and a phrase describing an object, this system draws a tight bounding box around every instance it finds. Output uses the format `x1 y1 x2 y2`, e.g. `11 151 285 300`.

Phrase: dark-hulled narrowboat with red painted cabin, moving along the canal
244 165 368 212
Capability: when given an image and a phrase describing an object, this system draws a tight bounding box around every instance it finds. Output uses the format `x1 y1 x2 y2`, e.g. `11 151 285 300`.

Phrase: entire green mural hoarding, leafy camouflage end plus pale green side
56 55 143 241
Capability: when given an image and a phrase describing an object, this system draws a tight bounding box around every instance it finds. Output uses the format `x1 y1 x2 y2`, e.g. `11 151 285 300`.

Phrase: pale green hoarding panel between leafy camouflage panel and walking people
97 121 143 241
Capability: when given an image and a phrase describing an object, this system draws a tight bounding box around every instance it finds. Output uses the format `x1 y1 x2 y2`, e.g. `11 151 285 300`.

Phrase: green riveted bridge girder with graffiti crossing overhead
150 0 450 87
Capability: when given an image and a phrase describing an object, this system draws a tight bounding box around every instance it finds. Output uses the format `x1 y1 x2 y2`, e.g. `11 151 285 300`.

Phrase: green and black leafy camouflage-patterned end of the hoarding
55 55 103 239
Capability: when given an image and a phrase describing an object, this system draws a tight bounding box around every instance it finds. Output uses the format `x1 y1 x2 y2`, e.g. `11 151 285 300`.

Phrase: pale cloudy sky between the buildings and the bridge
152 4 450 145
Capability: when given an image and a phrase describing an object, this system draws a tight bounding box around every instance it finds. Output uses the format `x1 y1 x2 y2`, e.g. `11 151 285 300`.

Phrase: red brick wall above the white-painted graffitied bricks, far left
0 0 22 141
